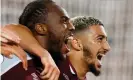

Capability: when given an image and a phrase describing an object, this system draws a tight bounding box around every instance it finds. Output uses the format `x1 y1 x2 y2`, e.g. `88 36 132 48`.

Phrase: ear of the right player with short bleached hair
71 39 83 51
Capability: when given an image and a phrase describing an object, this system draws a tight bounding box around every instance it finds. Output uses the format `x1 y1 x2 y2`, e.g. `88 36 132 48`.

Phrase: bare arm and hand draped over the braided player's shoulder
3 24 60 80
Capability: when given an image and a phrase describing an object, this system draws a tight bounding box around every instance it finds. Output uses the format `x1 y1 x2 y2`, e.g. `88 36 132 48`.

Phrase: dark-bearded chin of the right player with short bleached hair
90 63 101 76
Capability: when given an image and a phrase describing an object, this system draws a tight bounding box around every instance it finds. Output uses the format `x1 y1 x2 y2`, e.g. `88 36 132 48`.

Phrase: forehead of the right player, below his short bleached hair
89 25 107 37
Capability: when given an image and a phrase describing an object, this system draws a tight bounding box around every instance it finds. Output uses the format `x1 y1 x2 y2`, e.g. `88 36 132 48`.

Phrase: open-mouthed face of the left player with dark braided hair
46 4 74 51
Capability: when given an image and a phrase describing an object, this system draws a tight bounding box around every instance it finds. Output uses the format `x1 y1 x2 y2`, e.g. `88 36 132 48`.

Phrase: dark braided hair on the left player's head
19 0 53 30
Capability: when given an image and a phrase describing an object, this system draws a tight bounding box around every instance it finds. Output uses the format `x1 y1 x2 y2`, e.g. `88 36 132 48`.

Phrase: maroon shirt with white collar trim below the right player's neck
57 57 86 80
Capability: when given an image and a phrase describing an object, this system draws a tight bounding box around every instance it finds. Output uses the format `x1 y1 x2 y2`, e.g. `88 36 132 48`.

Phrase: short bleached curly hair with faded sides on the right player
72 16 104 32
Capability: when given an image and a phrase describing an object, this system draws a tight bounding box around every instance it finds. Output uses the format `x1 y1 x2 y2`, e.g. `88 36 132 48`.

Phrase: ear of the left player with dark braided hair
35 23 48 35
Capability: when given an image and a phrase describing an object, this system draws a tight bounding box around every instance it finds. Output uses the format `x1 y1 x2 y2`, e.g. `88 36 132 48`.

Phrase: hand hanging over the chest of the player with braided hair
40 54 60 80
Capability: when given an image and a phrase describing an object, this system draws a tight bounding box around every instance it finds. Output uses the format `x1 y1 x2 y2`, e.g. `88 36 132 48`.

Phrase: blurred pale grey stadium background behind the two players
1 0 133 80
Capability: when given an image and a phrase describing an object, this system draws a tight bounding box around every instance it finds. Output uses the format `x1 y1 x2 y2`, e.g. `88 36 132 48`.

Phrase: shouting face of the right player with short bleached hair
81 25 110 76
